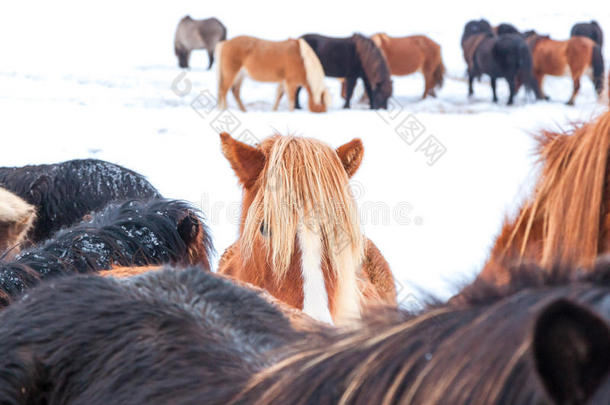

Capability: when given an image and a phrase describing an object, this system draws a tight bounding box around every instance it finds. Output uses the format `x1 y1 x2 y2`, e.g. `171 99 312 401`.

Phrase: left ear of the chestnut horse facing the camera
220 132 265 188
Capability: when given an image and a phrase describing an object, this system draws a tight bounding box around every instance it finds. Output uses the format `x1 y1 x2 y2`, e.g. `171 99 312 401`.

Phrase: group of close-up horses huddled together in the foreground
0 107 610 405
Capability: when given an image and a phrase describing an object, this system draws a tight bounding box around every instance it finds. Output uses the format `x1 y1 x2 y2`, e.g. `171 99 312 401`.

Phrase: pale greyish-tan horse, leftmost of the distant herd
174 15 227 70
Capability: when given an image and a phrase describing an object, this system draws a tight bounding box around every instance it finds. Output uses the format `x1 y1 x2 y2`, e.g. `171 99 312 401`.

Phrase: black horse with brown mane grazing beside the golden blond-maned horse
296 34 392 109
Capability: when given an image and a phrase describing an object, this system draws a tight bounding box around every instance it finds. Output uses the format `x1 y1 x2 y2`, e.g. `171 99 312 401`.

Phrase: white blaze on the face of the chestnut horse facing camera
298 224 333 324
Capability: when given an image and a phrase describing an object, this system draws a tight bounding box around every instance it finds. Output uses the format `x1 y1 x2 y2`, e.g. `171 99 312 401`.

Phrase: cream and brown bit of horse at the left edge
0 187 36 256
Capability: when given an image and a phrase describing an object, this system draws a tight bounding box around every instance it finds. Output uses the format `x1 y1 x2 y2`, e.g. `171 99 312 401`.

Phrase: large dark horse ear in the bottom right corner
533 299 610 404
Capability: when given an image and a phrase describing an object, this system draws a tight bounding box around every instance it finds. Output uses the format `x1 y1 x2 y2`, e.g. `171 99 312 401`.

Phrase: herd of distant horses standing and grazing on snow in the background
175 16 605 112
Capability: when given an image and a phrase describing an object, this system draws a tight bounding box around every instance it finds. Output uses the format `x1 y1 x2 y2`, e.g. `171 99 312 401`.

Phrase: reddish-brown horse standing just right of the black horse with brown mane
371 33 445 98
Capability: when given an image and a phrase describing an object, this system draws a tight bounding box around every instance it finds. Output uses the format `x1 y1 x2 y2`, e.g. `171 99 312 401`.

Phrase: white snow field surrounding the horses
0 0 610 299
